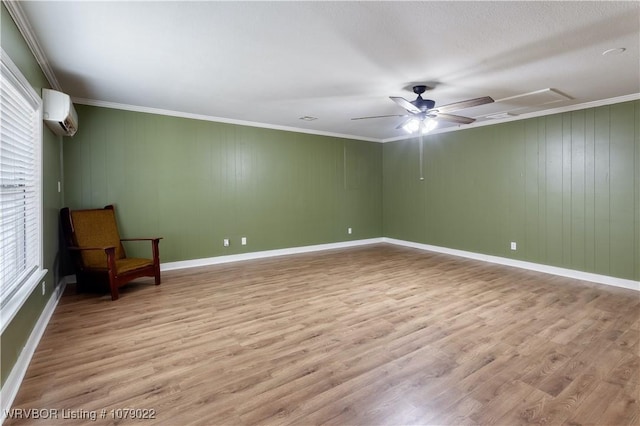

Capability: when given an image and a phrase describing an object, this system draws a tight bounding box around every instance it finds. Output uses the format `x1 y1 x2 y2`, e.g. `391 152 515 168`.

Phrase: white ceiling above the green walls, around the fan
10 1 640 141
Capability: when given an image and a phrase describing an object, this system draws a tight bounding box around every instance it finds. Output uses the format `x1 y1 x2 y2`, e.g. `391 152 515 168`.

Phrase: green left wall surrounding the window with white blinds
0 4 62 385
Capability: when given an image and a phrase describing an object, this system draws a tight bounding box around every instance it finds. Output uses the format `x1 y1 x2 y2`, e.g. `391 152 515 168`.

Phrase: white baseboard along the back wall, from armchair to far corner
160 238 384 271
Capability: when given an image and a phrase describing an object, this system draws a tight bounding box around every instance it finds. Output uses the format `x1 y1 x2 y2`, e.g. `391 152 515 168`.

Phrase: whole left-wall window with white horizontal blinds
0 51 43 330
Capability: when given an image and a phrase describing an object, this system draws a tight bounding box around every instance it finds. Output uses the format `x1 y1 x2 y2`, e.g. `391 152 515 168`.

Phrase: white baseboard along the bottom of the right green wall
382 237 640 291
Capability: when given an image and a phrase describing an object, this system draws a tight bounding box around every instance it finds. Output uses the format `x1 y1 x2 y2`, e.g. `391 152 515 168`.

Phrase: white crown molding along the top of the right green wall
381 93 640 143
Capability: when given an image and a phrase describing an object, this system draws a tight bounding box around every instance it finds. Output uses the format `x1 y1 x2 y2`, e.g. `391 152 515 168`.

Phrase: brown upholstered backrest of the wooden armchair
70 206 126 268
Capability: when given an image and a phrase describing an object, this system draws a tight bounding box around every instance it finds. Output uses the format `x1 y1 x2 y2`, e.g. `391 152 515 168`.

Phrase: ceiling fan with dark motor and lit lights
352 85 493 133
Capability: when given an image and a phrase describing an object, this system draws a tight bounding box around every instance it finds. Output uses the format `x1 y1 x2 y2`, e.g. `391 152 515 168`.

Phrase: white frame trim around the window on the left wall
0 48 47 333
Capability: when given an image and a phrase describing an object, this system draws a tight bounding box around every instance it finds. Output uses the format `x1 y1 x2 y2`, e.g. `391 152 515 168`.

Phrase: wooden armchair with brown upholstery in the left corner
60 205 162 300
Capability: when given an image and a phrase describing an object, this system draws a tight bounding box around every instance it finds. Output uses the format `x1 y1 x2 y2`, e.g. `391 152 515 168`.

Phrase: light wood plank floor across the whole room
6 245 640 425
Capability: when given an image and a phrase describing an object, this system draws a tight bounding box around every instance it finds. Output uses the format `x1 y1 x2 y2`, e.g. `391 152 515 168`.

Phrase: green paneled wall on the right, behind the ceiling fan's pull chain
383 101 640 280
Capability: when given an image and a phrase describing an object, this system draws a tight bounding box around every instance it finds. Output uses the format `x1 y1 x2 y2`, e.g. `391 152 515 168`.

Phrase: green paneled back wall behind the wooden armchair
63 105 382 262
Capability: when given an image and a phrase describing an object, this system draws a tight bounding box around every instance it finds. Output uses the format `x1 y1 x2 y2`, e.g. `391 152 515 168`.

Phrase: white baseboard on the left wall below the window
0 278 67 424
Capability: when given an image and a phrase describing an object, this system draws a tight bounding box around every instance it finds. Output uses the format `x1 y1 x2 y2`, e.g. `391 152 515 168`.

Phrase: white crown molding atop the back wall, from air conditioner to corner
72 97 382 143
